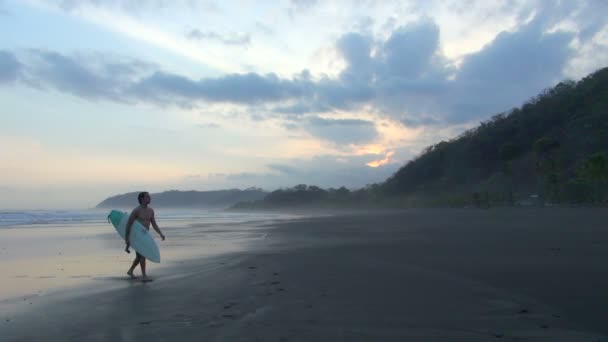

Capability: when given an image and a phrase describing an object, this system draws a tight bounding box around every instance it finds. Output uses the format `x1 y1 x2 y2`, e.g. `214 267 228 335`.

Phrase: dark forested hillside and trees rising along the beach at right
234 68 608 209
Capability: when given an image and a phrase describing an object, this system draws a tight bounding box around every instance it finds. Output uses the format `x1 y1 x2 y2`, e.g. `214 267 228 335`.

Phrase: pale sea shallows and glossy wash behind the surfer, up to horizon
0 209 295 305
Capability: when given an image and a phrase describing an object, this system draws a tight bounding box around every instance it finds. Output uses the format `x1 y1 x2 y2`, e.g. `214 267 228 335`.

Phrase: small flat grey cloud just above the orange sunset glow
304 117 378 145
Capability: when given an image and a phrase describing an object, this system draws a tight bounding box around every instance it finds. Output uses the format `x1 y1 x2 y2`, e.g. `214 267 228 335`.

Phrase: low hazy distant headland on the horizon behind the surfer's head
96 188 268 209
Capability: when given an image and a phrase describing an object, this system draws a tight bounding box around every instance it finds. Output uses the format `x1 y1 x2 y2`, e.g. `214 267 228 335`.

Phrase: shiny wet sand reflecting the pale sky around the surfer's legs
0 215 296 312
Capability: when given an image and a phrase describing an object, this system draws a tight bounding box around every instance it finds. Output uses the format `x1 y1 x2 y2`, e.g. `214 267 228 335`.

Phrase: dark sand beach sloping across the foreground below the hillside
0 208 608 341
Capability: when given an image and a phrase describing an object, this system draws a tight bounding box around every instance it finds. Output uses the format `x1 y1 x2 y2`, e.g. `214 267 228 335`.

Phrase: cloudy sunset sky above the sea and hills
0 0 608 210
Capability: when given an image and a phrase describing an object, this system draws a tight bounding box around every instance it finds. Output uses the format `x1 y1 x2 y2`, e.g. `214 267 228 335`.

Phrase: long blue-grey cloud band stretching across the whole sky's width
0 2 606 126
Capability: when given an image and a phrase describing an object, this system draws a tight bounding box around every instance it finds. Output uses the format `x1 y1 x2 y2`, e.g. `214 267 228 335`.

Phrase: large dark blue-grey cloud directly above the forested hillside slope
443 17 574 122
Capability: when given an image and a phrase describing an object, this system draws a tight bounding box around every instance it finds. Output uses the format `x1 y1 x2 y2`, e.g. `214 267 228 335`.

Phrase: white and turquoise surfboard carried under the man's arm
108 210 160 263
